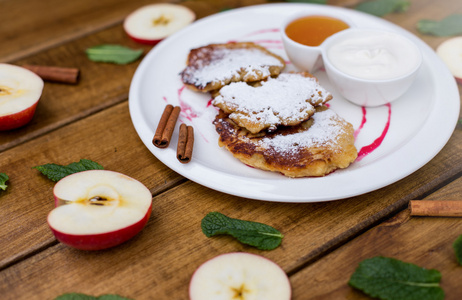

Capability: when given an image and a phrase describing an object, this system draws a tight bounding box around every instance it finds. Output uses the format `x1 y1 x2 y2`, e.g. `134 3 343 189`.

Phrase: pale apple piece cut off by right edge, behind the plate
436 36 462 84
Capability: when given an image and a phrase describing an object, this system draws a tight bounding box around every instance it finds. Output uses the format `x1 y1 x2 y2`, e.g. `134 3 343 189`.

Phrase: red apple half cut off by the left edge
0 64 44 131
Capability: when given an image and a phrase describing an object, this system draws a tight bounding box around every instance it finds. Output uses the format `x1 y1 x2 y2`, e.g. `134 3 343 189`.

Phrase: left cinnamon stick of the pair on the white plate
152 104 181 148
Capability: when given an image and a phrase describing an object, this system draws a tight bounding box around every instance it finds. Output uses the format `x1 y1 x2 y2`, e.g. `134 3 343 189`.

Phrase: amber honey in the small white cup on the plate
285 16 350 46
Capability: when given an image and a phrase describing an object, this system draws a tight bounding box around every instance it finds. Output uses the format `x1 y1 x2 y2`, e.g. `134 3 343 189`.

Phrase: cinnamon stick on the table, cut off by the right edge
409 200 462 217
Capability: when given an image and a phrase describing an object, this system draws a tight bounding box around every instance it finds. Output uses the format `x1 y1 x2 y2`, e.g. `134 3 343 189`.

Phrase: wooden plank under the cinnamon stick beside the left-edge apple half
0 25 151 151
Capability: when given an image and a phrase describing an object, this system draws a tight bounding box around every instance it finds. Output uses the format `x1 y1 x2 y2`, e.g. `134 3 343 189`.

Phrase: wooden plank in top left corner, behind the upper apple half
0 0 171 62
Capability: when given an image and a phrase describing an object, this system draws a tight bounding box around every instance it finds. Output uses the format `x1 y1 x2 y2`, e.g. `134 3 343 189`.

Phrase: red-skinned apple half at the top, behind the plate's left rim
124 3 196 45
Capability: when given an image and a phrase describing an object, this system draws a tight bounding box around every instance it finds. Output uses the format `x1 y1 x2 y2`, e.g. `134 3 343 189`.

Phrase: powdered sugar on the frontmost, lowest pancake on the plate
258 109 344 153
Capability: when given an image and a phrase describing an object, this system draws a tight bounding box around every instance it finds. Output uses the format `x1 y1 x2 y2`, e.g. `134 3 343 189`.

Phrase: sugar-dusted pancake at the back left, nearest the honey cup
180 42 285 92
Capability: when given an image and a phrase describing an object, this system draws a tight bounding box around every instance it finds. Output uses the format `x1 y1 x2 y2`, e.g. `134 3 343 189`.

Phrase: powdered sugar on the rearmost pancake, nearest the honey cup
184 48 283 87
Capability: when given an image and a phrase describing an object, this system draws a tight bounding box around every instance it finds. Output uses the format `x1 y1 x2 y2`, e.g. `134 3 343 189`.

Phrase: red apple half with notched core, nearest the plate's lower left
48 170 152 250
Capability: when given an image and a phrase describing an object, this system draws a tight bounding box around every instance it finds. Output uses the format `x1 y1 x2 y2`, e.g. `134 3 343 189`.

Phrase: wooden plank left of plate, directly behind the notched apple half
0 102 183 268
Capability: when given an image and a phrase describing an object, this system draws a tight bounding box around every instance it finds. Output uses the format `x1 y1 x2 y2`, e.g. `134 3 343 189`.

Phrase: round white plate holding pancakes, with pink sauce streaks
129 4 459 202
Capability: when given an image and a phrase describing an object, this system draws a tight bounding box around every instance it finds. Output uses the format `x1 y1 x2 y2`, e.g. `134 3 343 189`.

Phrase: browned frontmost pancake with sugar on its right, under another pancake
214 106 357 177
